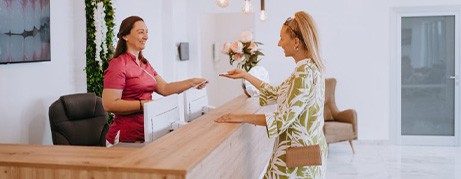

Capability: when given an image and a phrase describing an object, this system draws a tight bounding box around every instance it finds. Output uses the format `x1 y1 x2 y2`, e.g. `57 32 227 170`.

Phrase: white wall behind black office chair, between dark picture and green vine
0 0 86 144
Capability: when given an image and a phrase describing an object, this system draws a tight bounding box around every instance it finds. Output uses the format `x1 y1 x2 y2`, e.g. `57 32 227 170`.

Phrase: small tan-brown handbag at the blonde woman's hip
286 145 322 167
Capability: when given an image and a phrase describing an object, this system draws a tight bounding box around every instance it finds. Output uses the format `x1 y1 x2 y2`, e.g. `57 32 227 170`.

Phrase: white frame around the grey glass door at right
389 6 461 146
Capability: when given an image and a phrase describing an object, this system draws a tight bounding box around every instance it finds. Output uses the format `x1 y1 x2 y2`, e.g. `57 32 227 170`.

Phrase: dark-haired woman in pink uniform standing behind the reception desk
102 16 207 144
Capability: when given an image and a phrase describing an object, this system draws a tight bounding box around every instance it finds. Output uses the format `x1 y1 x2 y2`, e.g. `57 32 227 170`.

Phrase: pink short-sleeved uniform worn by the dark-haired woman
104 53 157 144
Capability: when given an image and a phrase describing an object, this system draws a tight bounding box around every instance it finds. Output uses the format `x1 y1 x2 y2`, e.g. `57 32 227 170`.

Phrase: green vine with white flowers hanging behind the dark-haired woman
84 0 115 96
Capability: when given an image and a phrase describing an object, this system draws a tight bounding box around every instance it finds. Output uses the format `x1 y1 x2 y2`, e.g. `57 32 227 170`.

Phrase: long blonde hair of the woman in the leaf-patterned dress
283 11 325 73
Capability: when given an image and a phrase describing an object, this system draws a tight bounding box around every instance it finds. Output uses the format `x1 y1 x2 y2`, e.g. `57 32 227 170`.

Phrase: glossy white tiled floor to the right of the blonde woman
326 141 461 179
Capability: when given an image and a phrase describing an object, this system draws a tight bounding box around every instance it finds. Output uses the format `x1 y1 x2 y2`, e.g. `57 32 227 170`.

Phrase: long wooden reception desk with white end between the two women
0 96 273 179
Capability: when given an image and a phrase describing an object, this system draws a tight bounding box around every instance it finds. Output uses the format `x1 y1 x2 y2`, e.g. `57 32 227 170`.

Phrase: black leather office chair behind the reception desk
48 93 109 146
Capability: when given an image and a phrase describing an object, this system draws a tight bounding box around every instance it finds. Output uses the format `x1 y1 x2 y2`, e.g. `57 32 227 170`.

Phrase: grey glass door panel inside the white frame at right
400 15 457 144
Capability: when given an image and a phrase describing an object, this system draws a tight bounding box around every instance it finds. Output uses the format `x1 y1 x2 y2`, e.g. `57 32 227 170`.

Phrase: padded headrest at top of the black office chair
59 93 98 120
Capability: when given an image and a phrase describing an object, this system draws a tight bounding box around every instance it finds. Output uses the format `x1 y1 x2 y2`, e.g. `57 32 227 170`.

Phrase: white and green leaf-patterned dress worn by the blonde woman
259 59 328 179
